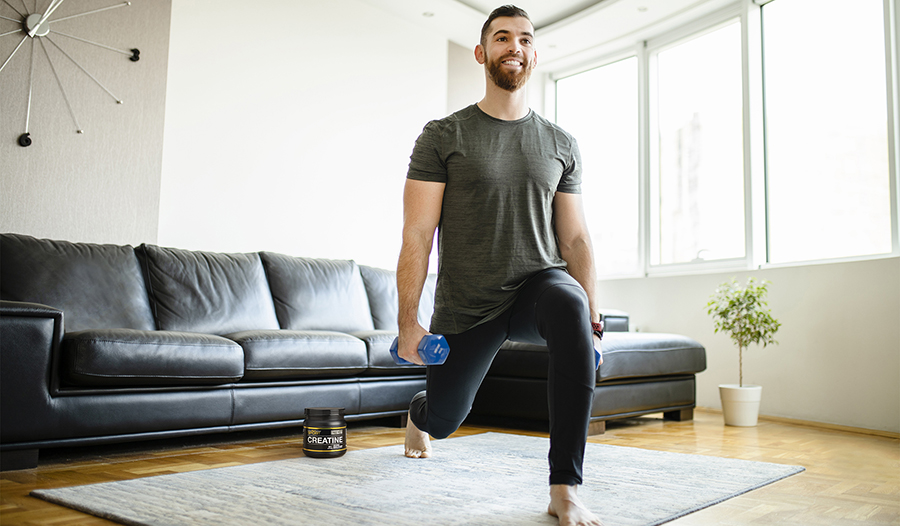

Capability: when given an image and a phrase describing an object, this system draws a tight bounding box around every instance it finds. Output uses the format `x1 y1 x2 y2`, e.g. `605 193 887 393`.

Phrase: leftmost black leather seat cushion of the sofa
60 329 244 387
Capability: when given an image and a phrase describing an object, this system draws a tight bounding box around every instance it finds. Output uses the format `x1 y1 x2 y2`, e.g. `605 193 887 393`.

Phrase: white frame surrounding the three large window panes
544 0 900 279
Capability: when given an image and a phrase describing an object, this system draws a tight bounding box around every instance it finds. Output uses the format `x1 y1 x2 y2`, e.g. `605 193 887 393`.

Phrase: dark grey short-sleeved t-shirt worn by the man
407 104 581 334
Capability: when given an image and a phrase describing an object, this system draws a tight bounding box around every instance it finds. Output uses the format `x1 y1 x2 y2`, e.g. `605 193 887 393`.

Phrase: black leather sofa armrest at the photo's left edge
0 301 63 444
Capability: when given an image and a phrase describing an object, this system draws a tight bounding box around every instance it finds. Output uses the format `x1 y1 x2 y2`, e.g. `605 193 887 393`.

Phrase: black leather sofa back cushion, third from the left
260 252 373 332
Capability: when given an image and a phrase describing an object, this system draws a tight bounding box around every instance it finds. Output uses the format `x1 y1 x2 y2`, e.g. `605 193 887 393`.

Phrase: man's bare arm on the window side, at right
553 192 600 356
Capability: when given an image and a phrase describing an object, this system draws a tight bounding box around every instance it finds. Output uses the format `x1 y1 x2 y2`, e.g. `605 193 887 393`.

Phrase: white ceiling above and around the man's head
363 0 740 68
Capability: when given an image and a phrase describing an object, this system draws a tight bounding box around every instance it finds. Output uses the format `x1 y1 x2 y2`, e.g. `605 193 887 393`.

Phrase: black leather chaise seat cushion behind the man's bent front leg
488 332 706 382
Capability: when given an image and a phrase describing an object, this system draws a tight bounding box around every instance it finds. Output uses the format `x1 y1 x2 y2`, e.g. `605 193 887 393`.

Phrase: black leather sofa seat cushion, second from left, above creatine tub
227 330 368 381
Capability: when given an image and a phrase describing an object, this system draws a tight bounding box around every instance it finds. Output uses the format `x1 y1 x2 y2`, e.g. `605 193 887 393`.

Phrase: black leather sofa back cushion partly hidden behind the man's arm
359 265 437 331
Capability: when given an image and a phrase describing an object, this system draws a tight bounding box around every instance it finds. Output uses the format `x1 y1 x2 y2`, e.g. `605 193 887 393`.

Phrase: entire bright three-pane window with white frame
555 0 900 277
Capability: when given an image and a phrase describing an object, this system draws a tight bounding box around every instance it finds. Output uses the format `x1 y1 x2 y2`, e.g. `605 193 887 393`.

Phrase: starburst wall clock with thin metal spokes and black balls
0 0 141 147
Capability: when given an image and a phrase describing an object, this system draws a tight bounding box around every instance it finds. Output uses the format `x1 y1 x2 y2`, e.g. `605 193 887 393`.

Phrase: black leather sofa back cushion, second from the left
136 244 278 335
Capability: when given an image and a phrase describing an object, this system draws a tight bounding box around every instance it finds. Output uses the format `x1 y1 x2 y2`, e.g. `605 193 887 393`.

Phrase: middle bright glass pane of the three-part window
649 20 745 265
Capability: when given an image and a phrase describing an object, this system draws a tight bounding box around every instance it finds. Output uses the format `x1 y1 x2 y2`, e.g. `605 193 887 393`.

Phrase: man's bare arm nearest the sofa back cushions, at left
397 179 445 365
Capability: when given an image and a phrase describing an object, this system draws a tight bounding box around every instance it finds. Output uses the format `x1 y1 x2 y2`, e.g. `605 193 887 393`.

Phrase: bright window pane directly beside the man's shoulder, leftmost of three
556 57 641 276
